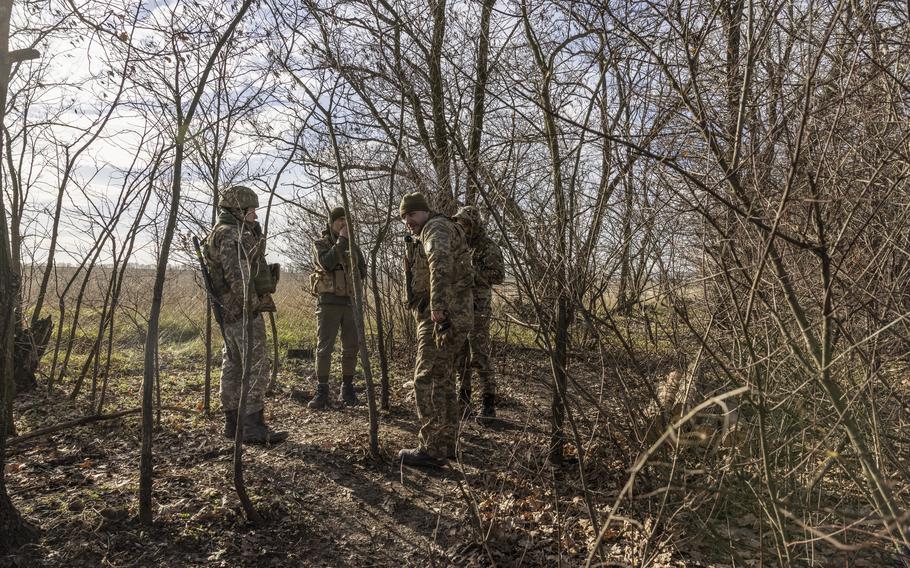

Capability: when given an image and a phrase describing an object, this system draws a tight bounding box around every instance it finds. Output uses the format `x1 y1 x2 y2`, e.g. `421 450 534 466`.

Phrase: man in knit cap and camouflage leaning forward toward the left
398 193 474 466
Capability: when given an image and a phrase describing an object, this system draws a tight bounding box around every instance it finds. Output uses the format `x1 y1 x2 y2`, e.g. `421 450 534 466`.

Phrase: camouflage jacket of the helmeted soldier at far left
204 212 275 323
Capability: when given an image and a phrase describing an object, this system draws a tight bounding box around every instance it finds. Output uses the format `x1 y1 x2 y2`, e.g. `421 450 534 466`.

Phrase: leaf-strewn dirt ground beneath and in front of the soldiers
0 344 669 567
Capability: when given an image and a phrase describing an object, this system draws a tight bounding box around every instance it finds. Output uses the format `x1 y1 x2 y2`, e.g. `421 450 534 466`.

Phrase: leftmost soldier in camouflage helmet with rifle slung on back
204 185 288 444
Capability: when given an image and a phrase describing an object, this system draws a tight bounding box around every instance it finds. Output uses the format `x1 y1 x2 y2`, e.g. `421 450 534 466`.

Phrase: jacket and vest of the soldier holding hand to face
310 230 367 304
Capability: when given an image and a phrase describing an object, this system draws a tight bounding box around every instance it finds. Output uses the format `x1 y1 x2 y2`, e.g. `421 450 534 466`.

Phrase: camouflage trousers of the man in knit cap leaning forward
414 294 474 457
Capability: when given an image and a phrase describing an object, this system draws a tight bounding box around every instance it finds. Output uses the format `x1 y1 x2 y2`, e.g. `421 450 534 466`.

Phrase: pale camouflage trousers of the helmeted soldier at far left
220 314 271 414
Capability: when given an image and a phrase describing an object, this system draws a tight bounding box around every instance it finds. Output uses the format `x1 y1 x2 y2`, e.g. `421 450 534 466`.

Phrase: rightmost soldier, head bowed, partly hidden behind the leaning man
454 205 505 418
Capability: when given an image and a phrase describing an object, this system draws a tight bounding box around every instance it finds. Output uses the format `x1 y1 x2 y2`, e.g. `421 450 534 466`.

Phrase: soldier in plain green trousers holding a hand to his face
307 207 367 410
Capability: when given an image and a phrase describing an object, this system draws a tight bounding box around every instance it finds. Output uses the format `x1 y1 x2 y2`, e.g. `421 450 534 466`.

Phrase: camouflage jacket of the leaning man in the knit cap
405 213 474 311
